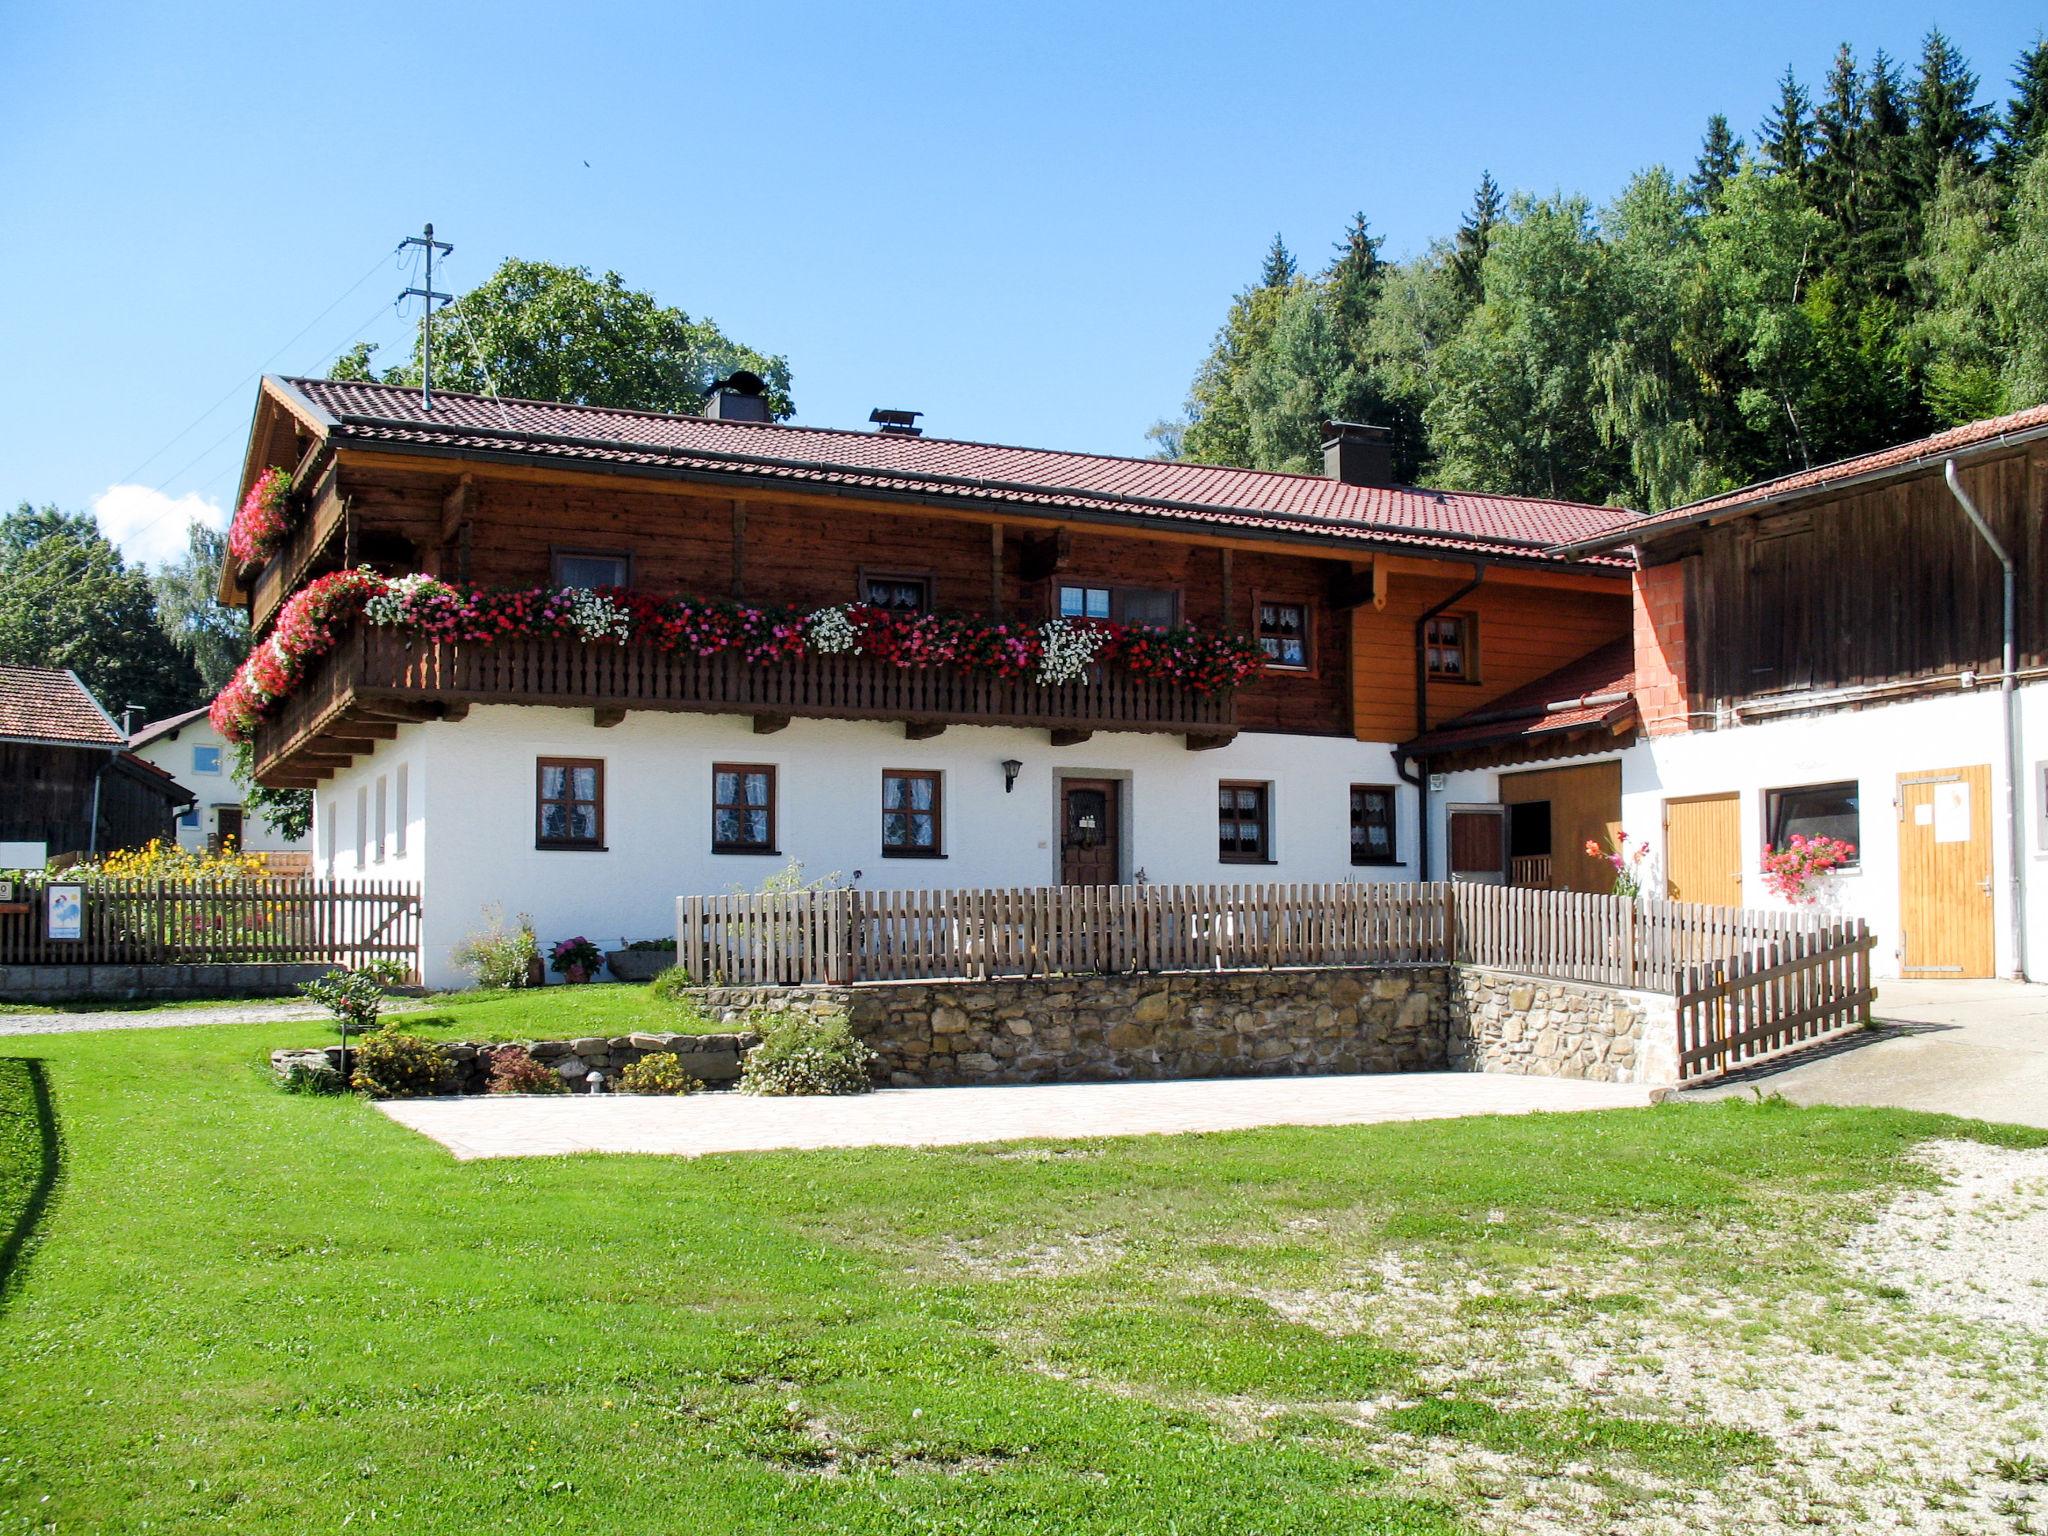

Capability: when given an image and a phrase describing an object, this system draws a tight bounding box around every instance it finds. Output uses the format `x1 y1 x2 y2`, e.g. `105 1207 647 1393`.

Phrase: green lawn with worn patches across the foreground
0 1024 2048 1536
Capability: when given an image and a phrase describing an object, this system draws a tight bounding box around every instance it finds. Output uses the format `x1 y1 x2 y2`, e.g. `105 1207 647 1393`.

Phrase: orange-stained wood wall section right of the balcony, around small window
1352 565 1632 741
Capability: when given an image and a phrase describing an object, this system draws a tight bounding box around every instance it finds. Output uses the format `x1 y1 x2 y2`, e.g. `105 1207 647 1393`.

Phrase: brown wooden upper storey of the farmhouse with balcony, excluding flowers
221 379 1630 784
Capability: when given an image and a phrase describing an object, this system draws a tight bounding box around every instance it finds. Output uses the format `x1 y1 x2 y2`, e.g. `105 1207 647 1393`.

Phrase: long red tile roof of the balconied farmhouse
274 379 1634 559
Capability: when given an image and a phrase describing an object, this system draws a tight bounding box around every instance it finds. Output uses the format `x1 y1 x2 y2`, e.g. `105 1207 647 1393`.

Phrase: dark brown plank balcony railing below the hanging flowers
256 625 1237 788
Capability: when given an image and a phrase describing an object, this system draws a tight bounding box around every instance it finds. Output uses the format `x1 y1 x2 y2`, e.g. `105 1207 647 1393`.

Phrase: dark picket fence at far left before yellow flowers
0 877 420 981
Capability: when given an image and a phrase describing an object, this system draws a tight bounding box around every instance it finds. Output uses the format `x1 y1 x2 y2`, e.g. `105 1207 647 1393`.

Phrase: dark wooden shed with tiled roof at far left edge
0 668 193 868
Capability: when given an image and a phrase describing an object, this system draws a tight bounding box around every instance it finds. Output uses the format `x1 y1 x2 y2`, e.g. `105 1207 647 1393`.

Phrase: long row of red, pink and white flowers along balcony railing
209 569 1266 741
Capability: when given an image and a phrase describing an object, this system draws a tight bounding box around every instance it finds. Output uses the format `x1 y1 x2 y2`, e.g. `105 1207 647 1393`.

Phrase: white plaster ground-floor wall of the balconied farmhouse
315 705 1415 987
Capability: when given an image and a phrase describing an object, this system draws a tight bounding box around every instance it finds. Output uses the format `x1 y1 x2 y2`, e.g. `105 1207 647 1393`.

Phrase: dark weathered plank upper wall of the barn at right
1686 451 2048 709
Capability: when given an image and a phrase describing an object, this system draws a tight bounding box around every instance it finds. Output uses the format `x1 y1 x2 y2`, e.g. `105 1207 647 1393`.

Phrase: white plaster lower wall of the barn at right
1622 684 2048 979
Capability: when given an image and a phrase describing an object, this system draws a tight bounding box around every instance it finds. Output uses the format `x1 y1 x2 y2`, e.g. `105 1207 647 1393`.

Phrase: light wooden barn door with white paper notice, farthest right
1898 764 1997 977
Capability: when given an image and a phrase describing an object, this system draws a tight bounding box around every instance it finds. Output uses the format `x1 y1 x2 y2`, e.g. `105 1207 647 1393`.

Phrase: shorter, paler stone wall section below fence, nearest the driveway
1448 965 1677 1085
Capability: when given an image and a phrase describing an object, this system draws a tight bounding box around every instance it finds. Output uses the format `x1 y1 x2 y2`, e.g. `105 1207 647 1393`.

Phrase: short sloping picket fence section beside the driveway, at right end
1677 920 1878 1083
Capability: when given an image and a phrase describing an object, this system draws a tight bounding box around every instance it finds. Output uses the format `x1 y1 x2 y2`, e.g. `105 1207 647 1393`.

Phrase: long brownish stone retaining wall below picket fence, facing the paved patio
692 967 1450 1087
